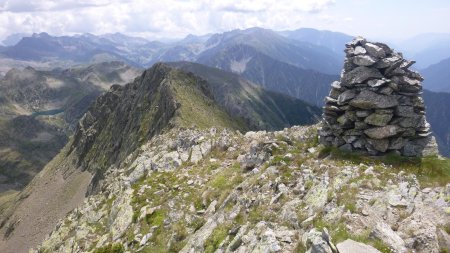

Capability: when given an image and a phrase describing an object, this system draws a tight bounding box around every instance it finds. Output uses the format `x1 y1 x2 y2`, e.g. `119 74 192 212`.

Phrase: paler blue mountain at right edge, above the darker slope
421 58 450 92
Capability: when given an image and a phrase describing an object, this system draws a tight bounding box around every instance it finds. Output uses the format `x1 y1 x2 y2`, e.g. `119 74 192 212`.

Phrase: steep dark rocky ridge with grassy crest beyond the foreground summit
0 63 319 253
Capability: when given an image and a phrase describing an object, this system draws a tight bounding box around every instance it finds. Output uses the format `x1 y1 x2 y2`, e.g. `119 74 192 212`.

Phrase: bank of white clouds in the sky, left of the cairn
0 0 335 38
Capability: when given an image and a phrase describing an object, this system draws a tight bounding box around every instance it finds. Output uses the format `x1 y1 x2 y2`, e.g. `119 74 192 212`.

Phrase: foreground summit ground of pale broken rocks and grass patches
36 126 450 253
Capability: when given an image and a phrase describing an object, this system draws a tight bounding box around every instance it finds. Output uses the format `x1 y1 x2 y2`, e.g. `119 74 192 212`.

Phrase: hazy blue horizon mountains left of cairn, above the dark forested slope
0 28 342 74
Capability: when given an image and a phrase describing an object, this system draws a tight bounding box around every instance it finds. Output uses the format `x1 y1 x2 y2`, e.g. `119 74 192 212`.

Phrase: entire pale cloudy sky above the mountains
0 0 450 40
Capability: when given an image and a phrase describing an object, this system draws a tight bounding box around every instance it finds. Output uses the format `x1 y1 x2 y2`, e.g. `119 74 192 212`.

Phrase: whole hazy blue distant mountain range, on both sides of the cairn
0 28 450 157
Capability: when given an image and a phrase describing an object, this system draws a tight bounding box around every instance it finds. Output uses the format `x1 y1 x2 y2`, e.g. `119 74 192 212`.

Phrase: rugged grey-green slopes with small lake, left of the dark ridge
0 62 141 193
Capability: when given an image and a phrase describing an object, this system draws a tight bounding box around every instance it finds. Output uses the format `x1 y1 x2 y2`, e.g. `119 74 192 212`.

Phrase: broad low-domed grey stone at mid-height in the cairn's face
349 90 398 109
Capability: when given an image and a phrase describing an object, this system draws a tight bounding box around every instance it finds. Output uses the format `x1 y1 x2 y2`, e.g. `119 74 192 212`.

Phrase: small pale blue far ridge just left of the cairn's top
280 28 353 57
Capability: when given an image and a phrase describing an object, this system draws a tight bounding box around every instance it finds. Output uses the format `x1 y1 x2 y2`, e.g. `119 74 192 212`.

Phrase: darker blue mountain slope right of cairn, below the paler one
423 90 450 157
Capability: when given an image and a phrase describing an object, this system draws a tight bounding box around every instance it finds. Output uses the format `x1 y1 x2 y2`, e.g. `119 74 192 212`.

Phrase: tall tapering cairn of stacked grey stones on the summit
319 37 436 156
